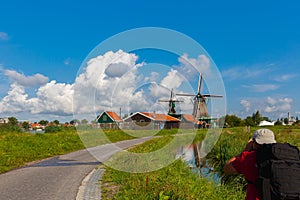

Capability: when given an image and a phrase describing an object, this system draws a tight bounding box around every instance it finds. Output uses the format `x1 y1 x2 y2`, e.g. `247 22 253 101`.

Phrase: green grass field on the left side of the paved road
0 126 142 173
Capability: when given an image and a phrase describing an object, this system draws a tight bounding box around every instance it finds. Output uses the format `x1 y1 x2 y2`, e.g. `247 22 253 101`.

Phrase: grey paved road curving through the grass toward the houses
0 138 154 200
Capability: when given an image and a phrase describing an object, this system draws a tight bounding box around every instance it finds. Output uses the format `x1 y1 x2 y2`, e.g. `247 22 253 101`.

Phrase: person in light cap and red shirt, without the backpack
224 129 276 200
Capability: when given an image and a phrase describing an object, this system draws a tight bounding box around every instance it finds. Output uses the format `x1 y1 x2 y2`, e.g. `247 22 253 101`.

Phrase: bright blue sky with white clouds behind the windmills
0 0 300 122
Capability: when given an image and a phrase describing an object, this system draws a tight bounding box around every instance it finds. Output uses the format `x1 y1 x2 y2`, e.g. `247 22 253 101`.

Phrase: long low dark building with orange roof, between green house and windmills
124 112 180 129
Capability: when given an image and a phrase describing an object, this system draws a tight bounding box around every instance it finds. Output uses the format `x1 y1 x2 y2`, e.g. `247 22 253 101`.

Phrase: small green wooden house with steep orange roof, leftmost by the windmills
96 111 122 129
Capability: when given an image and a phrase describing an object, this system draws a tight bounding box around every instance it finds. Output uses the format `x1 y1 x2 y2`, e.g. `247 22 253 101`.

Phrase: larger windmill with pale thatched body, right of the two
176 74 223 126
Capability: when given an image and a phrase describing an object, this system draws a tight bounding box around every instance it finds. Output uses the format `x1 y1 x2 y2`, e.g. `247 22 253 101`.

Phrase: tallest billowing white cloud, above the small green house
74 50 148 113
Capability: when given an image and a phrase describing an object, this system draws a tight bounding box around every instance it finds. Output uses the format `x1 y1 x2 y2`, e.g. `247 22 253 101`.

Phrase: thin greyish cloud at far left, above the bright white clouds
4 70 49 87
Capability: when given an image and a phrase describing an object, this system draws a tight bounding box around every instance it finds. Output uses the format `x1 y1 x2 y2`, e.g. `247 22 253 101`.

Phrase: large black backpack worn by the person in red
255 143 300 200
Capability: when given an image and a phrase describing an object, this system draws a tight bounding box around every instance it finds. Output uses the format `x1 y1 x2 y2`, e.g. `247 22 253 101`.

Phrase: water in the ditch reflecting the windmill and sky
176 143 220 184
